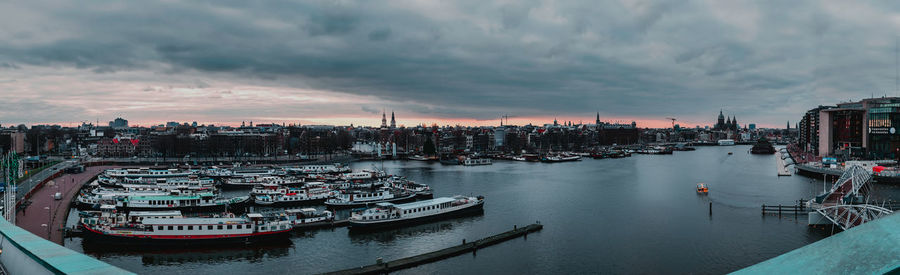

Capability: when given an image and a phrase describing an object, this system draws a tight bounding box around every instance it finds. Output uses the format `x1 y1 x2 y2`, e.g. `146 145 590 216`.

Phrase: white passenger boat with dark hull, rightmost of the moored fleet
350 196 484 229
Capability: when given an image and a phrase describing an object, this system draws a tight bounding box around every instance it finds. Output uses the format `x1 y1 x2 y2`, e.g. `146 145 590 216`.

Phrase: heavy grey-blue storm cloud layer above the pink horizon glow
0 1 898 124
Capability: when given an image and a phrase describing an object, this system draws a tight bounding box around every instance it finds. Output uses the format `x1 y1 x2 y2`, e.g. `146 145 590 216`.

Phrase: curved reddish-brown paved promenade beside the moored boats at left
16 166 110 243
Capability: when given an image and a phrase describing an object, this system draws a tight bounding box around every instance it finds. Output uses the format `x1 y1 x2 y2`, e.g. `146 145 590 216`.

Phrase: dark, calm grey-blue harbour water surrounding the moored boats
66 146 897 274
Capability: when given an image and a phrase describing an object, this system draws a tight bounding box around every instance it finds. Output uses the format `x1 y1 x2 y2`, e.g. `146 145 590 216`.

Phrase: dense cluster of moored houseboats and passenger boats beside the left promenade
75 166 484 245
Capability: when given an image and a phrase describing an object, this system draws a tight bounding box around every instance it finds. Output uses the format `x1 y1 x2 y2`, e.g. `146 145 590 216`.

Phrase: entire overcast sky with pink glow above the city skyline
0 0 900 127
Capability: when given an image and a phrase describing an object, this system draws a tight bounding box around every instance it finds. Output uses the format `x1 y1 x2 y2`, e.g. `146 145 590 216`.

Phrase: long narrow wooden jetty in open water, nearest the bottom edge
325 223 544 275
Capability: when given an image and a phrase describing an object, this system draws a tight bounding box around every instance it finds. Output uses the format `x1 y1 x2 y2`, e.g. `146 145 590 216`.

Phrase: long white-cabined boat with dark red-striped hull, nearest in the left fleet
79 208 293 245
